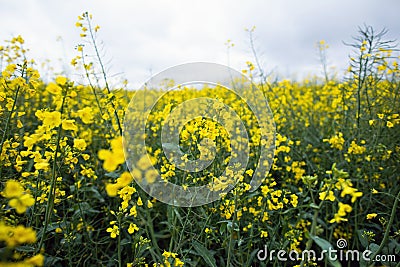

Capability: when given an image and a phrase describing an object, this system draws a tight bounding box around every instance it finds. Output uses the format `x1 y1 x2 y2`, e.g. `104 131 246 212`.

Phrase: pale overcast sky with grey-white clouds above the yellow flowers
0 0 400 86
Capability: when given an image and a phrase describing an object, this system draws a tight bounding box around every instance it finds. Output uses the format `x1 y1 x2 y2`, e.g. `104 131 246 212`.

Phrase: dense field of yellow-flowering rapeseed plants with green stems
0 13 400 267
